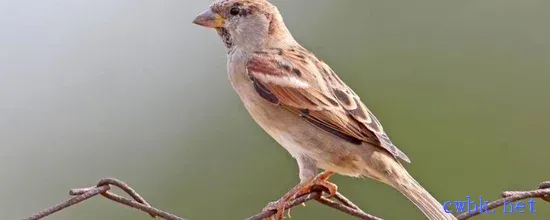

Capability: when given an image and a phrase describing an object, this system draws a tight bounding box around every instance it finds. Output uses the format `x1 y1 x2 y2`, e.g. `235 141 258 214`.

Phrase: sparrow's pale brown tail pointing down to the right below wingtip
387 168 456 220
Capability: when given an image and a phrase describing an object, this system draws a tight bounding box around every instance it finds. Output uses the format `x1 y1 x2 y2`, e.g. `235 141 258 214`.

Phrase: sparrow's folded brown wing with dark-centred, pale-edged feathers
247 47 410 162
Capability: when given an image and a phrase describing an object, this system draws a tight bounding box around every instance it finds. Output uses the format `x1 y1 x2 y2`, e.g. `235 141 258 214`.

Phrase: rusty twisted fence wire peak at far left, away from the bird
25 178 183 220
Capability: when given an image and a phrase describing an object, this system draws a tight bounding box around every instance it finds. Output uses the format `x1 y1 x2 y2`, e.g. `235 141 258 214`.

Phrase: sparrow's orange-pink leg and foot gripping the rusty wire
263 171 338 220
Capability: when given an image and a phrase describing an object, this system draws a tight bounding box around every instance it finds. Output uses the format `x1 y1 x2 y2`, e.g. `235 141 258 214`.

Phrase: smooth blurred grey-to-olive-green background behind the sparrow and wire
0 0 550 220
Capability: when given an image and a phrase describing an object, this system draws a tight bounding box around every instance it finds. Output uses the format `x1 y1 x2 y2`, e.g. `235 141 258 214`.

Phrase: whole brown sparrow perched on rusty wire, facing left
193 0 456 220
